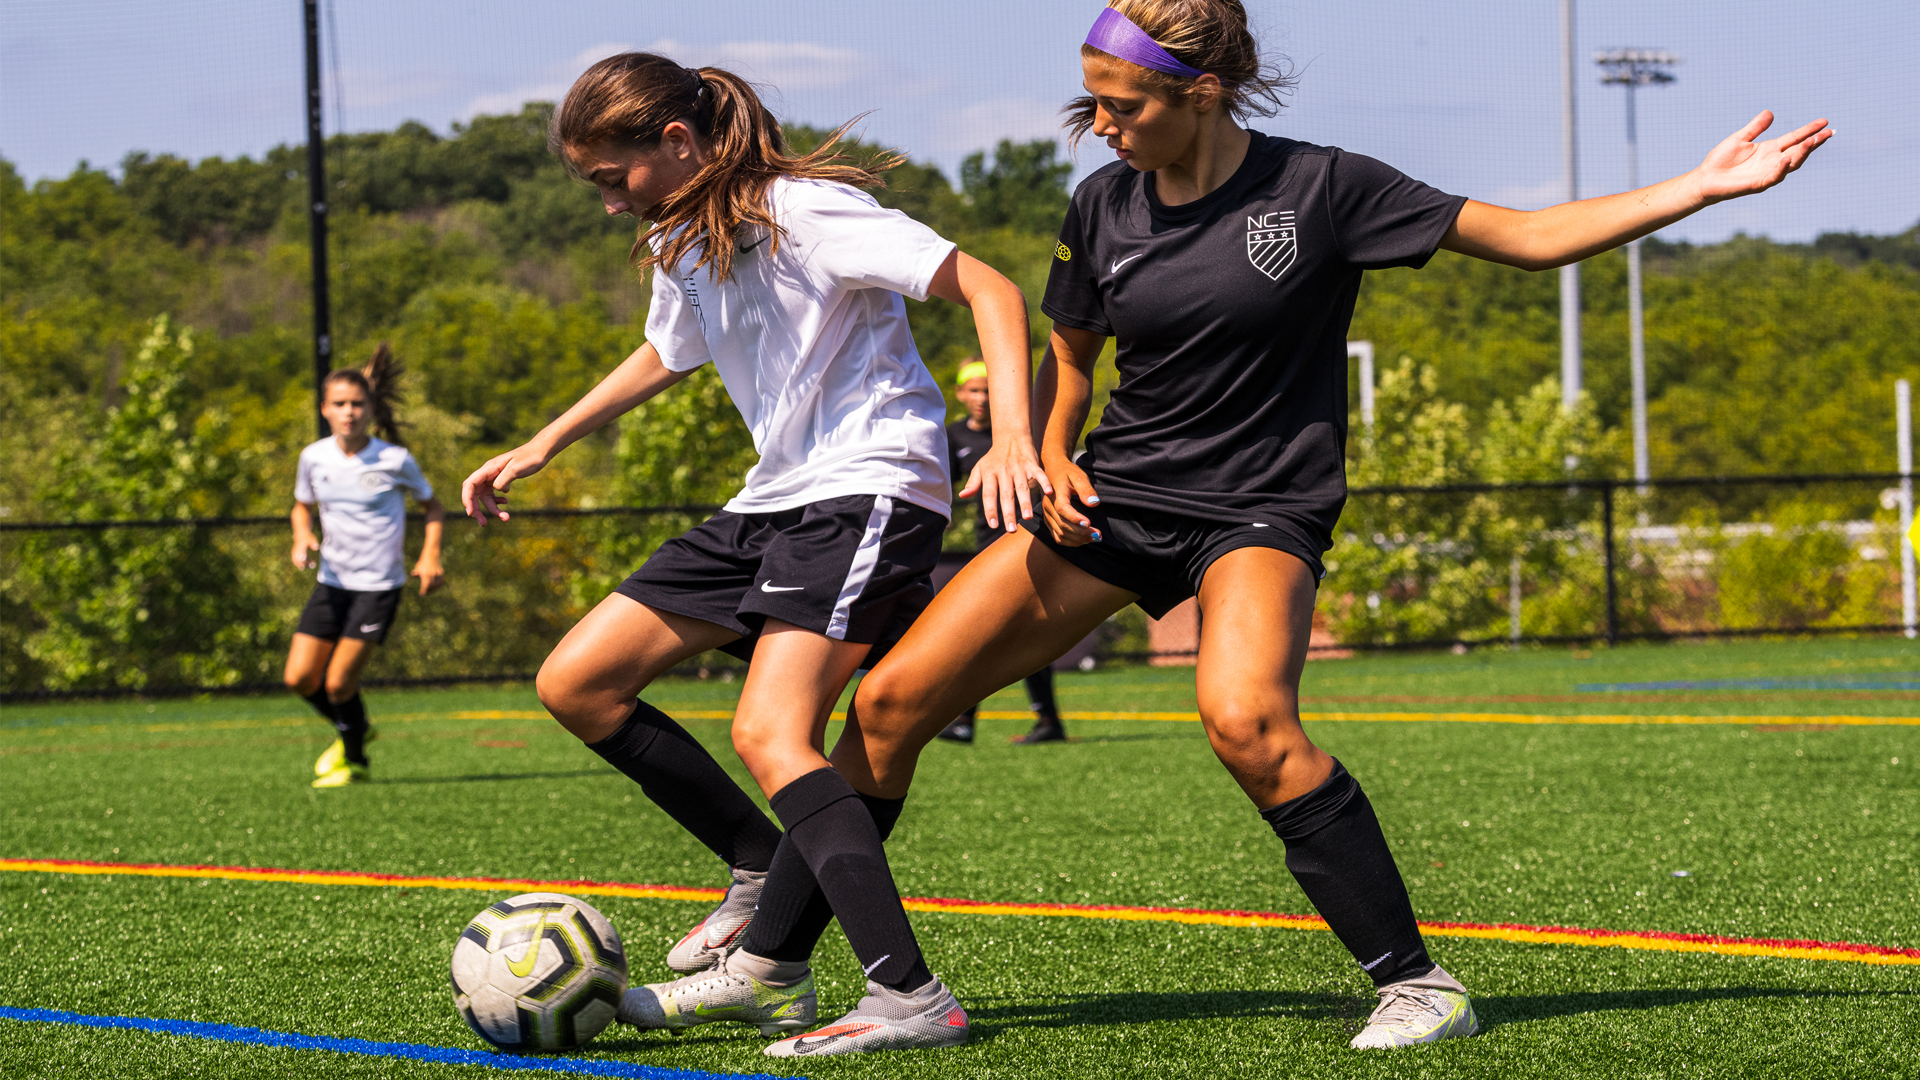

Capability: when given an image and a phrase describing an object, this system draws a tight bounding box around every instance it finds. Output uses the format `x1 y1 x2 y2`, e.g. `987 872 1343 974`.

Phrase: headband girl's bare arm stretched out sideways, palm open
1440 111 1834 271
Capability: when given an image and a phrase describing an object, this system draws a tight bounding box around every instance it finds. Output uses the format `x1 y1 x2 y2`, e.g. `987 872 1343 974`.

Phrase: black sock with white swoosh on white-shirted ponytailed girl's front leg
749 769 933 994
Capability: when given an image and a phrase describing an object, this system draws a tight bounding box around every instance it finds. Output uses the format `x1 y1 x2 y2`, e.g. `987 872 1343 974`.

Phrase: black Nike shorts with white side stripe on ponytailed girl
614 496 947 667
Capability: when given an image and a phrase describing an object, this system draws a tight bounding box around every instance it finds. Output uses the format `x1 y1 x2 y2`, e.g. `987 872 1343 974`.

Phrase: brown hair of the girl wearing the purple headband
1060 0 1298 146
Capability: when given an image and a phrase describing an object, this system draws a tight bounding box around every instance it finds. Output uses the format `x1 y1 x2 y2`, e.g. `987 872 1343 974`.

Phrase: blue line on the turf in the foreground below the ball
0 1005 776 1080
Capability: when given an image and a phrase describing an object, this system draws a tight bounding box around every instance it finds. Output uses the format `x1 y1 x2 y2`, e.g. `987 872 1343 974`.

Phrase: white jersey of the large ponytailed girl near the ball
647 177 954 515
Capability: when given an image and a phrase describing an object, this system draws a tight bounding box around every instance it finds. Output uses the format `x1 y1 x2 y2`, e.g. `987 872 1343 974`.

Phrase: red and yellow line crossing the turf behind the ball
0 859 1920 965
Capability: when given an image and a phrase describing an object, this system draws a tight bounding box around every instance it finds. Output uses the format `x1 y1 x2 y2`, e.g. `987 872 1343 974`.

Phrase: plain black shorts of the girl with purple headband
1025 505 1327 619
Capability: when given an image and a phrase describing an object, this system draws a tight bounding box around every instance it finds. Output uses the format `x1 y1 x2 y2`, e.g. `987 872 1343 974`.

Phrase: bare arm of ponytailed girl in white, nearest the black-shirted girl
927 250 1052 532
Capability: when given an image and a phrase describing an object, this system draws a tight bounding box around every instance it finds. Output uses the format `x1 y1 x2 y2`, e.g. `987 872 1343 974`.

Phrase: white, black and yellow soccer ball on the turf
453 892 626 1049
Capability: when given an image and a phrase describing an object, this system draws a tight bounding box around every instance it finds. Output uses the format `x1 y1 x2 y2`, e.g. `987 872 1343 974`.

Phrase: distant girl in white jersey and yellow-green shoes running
286 342 445 788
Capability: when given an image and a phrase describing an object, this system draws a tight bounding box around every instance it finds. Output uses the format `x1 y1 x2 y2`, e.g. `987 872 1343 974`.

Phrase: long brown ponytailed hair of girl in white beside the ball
547 52 902 281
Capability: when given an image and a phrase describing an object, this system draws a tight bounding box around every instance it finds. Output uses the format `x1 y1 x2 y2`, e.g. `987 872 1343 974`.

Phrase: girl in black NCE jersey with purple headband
835 0 1832 1047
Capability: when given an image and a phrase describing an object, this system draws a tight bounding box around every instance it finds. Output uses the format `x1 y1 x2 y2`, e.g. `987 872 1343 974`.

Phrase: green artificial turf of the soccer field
0 640 1920 1078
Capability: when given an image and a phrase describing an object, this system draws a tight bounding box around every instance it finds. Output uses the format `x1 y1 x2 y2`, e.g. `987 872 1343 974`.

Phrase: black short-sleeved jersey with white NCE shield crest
1041 133 1467 552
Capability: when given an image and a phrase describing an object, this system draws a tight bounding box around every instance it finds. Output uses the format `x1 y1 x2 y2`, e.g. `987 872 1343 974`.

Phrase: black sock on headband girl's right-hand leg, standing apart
1260 761 1434 986
